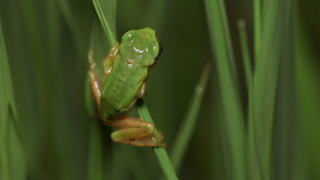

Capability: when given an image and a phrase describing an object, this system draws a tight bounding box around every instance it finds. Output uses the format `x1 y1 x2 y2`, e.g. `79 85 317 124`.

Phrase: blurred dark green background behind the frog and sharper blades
0 0 320 180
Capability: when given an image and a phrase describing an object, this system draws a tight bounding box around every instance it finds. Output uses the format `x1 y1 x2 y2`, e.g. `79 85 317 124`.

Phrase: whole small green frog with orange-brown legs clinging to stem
89 28 166 147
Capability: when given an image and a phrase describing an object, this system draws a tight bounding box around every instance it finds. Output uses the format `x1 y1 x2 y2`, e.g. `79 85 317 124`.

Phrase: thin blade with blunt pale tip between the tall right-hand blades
238 20 252 93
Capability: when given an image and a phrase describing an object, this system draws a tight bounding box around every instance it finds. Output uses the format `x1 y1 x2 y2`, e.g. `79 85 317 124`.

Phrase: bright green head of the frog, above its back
120 28 162 68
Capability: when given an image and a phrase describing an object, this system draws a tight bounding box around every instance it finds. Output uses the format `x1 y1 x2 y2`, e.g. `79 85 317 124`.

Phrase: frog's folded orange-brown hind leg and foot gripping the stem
105 116 166 147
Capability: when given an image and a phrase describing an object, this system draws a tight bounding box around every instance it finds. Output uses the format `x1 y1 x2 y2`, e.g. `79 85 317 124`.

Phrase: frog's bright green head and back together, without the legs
101 28 161 120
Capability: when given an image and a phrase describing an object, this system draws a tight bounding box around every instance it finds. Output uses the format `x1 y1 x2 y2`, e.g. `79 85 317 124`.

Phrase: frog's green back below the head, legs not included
101 56 148 120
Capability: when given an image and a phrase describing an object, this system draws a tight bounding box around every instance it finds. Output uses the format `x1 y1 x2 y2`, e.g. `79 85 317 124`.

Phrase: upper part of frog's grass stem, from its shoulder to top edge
92 0 117 45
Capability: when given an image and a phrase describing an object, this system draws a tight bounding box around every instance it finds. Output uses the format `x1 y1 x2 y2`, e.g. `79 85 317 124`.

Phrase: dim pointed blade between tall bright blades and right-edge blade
271 11 296 179
